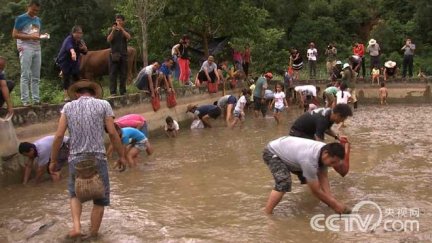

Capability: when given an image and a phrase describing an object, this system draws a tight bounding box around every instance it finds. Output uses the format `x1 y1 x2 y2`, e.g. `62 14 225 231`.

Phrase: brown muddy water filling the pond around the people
0 105 432 242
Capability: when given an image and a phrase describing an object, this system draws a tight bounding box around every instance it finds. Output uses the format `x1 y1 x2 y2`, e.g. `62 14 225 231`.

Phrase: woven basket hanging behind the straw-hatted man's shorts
75 160 105 202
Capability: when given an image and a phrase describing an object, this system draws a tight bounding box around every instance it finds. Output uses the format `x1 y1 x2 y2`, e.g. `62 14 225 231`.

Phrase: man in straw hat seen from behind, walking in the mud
49 80 126 238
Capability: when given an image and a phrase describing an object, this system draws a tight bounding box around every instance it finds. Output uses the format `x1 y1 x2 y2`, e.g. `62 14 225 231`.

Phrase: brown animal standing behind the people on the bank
80 46 137 84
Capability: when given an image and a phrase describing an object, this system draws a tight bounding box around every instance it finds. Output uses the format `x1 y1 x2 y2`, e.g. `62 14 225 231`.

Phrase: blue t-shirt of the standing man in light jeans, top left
14 13 42 49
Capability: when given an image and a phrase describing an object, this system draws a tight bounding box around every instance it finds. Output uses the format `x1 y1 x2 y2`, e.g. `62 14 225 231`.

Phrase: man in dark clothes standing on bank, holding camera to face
107 14 131 96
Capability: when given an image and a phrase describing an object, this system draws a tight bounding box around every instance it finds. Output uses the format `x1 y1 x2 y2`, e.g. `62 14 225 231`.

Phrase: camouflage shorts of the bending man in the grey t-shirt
263 148 300 192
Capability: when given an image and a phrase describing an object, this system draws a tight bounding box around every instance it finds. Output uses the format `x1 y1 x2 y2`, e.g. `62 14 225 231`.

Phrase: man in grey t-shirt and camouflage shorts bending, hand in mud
263 137 350 214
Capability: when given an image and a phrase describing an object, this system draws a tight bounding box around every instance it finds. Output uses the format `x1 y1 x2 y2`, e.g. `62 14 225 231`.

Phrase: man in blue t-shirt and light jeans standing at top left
12 0 41 106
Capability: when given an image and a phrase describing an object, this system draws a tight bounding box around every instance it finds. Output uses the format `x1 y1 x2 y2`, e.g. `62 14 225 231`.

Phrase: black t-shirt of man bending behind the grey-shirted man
291 108 333 139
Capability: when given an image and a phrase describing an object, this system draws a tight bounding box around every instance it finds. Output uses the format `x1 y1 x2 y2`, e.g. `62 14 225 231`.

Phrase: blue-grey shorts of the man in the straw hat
68 153 110 206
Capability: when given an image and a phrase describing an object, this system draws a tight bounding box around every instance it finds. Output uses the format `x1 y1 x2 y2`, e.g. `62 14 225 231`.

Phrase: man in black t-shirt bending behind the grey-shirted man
289 104 353 177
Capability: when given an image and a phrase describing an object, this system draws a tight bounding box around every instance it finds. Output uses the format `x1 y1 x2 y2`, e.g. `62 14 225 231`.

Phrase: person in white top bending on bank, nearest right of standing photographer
135 62 160 98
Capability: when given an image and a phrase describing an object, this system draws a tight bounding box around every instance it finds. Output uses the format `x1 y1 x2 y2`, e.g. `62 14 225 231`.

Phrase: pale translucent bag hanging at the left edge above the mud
0 117 18 157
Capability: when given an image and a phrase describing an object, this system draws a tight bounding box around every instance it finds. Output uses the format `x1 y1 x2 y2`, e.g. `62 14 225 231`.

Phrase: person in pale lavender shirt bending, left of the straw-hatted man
18 136 69 184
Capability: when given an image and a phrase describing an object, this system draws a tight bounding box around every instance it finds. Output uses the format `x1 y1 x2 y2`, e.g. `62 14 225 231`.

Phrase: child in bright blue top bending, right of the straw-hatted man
107 125 153 170
